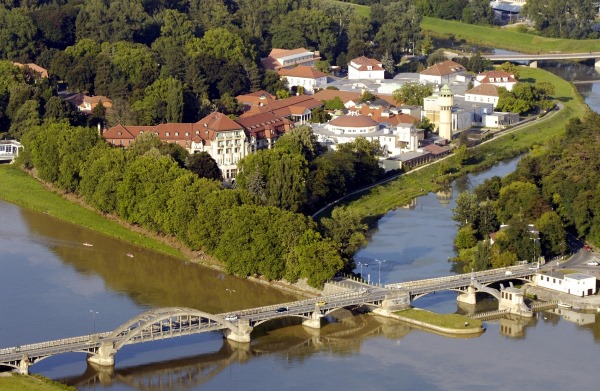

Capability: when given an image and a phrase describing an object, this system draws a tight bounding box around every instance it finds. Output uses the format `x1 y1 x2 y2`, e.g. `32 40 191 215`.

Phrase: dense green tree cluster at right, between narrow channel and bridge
453 113 600 270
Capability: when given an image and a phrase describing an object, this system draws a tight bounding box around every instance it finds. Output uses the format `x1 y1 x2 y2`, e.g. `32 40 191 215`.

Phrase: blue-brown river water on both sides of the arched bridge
0 63 600 391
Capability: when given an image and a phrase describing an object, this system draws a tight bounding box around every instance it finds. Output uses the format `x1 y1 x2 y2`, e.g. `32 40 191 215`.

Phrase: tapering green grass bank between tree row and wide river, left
0 164 183 258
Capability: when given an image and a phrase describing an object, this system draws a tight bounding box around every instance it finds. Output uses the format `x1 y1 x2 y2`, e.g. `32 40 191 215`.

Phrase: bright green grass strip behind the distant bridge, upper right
421 17 600 53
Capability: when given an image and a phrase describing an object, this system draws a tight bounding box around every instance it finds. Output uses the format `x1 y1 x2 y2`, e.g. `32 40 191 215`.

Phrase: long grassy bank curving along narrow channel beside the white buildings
346 67 589 222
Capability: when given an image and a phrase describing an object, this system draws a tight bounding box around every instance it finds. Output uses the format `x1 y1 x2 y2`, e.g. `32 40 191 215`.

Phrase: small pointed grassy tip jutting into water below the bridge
391 308 485 337
